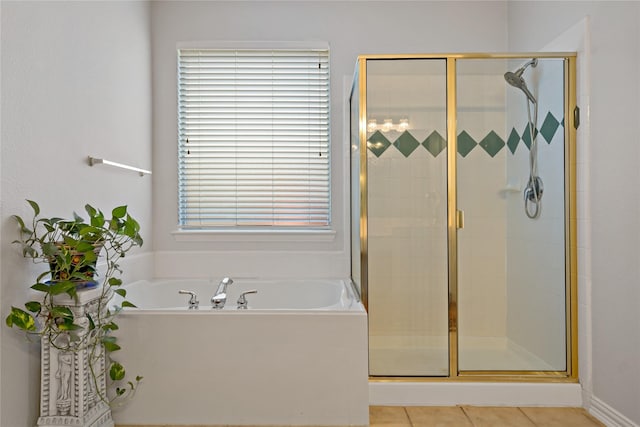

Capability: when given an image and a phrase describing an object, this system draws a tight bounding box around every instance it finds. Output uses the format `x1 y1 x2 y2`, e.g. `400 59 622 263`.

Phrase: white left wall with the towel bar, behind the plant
0 1 152 427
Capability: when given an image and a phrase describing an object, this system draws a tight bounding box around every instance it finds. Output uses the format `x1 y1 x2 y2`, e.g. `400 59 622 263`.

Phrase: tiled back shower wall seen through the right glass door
457 65 509 352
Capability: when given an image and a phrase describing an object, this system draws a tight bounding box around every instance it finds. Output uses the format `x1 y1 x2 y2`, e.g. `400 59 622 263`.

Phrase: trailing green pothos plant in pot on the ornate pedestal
6 200 143 404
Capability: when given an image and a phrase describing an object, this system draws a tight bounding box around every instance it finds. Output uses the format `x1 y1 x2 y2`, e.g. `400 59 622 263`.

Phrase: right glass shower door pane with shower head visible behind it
456 58 567 372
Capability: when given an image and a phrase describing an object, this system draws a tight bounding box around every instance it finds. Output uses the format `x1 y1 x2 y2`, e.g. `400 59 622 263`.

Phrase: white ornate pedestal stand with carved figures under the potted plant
38 287 114 427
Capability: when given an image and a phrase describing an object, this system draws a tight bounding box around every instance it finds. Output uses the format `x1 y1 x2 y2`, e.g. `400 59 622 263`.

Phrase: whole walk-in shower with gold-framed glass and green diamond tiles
350 53 577 381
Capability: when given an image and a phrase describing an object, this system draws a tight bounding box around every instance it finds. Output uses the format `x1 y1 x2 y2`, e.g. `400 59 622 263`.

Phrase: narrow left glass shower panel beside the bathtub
366 59 449 376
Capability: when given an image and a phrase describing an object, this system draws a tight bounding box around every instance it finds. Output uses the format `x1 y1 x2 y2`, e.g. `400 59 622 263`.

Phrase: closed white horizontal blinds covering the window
178 49 330 229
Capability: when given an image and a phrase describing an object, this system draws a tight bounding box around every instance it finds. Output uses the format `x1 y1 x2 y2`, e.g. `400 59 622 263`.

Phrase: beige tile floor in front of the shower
369 406 604 427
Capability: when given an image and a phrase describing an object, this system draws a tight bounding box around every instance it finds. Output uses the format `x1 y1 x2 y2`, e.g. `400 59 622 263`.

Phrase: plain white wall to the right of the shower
509 1 640 425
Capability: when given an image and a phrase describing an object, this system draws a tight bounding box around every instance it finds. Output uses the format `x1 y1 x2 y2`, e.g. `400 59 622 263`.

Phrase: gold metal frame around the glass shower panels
349 52 579 382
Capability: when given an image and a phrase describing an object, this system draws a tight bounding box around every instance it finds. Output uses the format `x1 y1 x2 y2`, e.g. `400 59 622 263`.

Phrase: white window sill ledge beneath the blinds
171 228 336 242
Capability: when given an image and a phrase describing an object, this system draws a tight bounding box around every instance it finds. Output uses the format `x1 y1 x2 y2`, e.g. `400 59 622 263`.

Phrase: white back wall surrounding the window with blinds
152 1 506 277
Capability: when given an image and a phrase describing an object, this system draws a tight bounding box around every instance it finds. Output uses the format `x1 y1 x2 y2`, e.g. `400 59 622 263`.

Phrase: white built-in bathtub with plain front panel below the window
113 278 369 426
